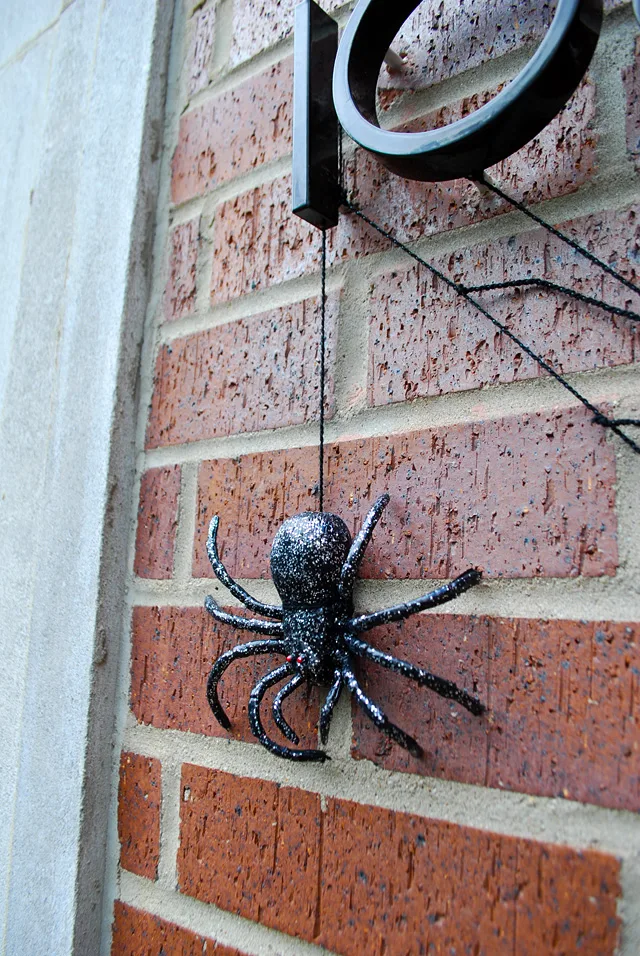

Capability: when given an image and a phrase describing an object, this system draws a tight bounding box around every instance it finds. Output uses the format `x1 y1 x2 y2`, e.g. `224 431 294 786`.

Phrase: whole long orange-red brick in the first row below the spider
178 765 620 956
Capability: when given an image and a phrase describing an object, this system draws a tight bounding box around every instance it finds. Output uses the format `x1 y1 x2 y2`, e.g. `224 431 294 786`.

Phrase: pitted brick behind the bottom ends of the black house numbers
211 82 596 302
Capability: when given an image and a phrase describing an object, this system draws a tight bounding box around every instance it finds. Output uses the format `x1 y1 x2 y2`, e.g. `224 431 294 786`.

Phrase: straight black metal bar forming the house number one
292 0 340 229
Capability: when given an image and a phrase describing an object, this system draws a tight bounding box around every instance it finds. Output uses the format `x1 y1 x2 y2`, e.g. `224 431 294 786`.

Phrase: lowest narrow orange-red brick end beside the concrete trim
118 752 162 880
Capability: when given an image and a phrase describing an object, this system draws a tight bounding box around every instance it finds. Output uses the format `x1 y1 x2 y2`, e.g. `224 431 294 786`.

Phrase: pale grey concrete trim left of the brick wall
0 0 173 956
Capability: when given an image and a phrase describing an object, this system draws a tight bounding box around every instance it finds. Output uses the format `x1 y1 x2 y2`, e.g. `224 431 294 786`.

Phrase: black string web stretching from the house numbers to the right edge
343 190 640 455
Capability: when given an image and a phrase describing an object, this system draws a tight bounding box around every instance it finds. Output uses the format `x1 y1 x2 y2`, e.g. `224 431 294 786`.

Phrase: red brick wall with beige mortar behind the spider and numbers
108 0 640 956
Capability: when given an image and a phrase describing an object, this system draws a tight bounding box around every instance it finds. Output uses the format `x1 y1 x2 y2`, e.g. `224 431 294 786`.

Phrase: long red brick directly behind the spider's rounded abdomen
193 408 617 578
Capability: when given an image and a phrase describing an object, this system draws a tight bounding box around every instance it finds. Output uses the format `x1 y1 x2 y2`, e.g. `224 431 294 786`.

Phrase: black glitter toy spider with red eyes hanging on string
204 494 485 760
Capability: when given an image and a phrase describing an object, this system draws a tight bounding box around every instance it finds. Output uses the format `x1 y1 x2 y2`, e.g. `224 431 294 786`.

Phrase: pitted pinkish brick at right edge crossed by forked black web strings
369 207 639 405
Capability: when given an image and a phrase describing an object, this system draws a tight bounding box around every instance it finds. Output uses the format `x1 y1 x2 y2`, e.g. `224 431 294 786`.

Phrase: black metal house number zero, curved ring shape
333 0 602 182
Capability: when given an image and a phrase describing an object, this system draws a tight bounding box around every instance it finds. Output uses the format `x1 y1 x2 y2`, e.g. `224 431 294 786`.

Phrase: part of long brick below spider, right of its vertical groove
321 800 620 956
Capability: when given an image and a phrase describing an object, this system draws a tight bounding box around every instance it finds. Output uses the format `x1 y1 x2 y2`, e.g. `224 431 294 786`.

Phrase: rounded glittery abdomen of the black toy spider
271 511 351 607
